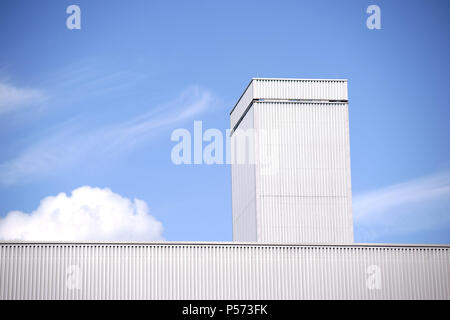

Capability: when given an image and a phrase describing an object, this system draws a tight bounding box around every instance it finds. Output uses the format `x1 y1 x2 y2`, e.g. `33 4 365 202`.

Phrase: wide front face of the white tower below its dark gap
252 102 353 243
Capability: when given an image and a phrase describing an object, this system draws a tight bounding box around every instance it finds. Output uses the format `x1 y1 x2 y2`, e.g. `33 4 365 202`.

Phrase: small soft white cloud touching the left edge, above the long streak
0 82 44 114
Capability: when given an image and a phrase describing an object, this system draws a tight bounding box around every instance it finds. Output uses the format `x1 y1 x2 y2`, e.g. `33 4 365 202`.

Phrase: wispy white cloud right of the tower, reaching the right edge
353 171 450 241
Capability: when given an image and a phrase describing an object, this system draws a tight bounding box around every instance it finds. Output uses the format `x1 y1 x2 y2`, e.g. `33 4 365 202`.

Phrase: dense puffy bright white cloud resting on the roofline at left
0 186 163 241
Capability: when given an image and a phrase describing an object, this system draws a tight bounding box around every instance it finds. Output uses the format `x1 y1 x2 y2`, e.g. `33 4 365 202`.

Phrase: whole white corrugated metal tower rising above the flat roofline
230 78 353 243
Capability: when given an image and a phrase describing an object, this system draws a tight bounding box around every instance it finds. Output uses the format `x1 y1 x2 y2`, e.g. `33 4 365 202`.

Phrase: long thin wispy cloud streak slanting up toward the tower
0 86 215 184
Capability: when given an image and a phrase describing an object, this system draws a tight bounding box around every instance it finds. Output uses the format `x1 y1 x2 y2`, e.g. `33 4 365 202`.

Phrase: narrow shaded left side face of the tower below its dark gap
231 109 257 241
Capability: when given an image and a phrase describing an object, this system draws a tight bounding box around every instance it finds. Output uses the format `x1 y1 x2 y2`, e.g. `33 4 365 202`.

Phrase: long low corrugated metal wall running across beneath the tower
0 243 450 299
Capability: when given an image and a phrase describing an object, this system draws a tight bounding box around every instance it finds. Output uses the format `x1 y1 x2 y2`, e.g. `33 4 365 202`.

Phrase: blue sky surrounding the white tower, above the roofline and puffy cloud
0 0 450 243
